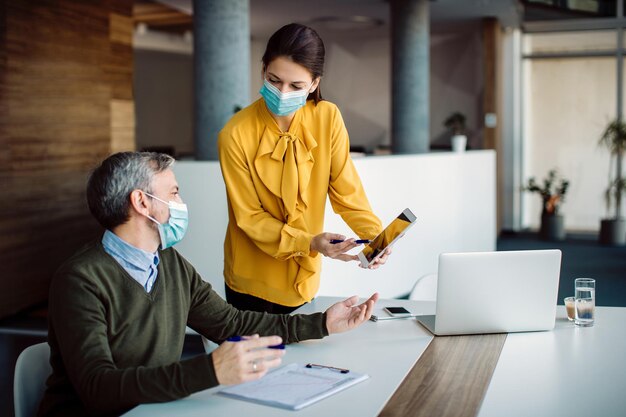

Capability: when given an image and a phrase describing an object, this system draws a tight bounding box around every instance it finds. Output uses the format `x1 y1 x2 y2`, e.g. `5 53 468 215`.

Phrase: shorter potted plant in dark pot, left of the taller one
524 169 569 240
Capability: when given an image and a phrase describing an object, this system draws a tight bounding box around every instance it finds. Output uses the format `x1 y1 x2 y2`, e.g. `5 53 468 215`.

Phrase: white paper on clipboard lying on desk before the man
218 363 369 410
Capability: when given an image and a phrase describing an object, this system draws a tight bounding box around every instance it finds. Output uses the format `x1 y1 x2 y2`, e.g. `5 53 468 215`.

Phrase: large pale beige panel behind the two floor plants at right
523 56 617 231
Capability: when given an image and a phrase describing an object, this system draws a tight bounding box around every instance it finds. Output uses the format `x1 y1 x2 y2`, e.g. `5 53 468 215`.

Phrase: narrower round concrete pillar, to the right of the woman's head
390 0 430 154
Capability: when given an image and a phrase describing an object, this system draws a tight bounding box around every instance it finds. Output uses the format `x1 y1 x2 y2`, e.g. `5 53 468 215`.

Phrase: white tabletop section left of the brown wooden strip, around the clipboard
125 297 435 417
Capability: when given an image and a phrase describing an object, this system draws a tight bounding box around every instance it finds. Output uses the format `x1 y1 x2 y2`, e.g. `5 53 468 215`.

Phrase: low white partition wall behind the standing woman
174 151 496 297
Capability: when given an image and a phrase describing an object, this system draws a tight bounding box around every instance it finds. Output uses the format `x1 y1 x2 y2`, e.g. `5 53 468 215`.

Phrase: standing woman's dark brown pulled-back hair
262 23 325 104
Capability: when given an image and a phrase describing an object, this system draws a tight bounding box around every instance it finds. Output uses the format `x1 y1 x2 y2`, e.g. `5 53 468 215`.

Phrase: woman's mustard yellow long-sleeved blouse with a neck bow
218 99 382 306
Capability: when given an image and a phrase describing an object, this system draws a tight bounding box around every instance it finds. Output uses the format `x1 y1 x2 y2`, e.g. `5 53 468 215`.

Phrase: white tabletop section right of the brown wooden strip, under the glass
478 306 626 417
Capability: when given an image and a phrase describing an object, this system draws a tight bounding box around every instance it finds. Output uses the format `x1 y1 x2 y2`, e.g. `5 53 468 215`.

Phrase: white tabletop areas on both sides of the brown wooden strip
127 297 626 417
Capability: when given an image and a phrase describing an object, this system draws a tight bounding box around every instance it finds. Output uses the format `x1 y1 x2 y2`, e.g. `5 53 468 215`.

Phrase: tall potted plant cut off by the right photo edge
600 119 626 246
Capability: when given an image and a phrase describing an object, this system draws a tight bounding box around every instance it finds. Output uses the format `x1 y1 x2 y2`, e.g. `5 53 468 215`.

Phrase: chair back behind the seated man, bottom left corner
13 343 52 417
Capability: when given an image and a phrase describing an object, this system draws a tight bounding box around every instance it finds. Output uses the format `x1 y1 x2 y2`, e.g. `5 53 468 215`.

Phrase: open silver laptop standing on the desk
418 249 561 336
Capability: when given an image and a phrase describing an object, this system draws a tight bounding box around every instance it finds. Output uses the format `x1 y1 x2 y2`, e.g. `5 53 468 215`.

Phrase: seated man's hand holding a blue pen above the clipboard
211 335 285 385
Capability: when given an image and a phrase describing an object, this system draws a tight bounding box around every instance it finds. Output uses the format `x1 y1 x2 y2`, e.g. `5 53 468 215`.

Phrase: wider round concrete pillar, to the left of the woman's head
193 0 250 160
